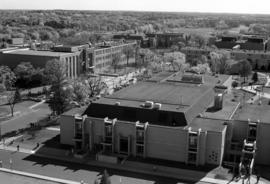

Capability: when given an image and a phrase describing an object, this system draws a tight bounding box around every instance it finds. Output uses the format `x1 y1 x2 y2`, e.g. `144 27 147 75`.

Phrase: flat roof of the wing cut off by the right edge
233 104 270 123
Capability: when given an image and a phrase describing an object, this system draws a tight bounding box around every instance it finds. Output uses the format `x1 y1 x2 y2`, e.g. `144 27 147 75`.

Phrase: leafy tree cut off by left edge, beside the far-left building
0 66 16 90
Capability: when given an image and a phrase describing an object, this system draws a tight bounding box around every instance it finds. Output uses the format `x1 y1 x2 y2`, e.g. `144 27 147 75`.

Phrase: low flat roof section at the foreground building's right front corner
187 117 226 132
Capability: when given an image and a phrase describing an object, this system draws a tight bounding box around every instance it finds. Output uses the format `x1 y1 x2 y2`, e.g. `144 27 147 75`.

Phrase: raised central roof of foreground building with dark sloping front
85 82 214 126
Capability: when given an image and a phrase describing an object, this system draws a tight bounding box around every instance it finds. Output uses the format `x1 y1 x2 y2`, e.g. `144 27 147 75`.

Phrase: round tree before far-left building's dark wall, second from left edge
14 62 35 88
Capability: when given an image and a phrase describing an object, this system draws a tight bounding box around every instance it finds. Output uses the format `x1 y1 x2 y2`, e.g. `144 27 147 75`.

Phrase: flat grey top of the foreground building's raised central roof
108 82 210 106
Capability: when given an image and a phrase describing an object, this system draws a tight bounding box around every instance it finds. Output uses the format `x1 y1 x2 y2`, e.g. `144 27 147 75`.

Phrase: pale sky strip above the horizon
0 0 270 14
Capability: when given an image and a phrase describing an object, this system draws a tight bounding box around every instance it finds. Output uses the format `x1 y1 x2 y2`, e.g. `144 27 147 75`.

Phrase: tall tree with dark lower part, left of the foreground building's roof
44 59 72 115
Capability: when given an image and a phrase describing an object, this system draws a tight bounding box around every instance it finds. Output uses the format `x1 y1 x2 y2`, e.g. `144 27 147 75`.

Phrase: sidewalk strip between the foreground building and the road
0 145 266 184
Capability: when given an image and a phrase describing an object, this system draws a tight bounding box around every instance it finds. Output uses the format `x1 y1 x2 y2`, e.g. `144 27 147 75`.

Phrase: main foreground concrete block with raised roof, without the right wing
60 74 238 165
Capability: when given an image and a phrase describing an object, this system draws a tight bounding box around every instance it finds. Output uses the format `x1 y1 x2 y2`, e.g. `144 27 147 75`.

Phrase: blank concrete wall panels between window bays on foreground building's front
60 115 226 165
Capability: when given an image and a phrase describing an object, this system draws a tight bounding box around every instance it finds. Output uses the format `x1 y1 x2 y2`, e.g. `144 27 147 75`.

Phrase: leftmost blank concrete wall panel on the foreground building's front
59 115 75 145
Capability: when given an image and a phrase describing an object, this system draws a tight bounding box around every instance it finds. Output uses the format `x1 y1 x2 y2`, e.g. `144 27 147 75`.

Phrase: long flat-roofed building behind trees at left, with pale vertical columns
0 41 137 78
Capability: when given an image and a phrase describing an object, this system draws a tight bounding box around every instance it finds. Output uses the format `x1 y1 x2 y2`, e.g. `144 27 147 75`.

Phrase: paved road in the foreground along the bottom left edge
0 150 198 184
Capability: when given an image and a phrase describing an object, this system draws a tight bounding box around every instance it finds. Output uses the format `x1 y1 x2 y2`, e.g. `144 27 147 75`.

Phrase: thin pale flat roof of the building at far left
5 50 72 57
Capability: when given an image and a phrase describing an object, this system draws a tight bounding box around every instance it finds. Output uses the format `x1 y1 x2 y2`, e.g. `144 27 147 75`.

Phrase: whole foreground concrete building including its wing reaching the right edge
60 71 270 172
